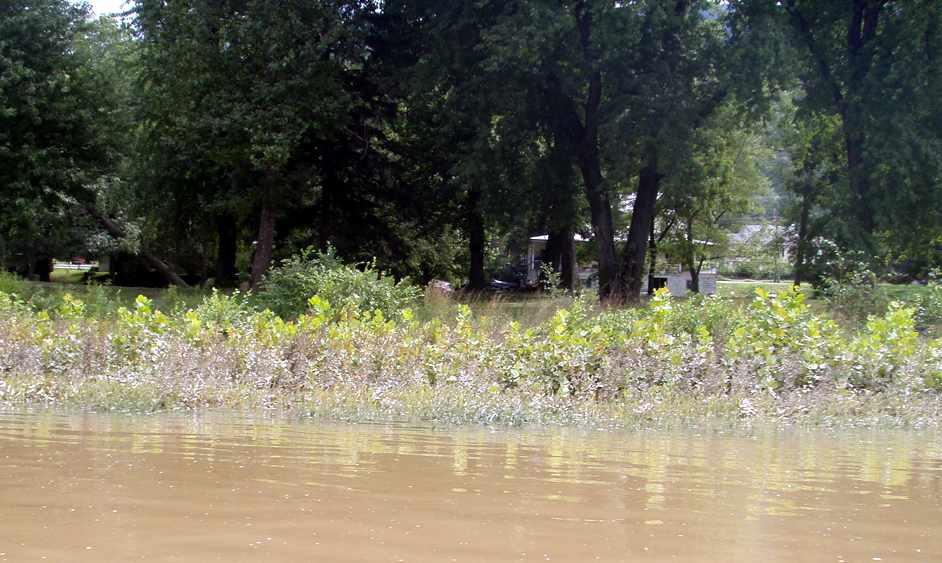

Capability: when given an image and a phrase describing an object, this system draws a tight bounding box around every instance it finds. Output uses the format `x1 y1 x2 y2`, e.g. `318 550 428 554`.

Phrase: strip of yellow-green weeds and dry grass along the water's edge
0 289 942 428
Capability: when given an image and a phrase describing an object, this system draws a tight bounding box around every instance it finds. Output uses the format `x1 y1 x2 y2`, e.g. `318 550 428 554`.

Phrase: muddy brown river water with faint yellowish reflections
0 413 942 561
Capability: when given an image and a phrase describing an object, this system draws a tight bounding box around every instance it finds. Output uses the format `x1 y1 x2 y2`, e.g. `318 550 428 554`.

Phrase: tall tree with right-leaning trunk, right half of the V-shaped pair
617 0 761 302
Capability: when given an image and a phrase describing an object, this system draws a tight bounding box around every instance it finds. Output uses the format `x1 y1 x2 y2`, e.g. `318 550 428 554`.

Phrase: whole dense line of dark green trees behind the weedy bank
0 0 942 301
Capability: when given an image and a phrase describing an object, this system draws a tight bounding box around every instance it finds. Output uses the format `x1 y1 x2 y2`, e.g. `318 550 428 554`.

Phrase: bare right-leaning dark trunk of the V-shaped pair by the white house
619 158 660 303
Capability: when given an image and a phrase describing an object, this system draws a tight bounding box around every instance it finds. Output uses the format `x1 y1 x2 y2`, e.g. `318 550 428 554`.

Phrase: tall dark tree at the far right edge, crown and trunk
784 0 942 251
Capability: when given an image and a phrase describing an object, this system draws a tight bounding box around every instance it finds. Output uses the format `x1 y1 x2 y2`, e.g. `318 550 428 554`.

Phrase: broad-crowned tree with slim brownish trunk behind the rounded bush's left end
136 0 367 288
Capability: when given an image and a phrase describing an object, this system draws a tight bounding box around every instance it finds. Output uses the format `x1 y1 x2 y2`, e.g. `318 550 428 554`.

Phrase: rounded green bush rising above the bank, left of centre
254 248 421 319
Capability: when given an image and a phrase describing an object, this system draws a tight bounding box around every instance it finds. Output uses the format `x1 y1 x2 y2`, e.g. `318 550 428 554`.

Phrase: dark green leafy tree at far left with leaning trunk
0 0 185 285
